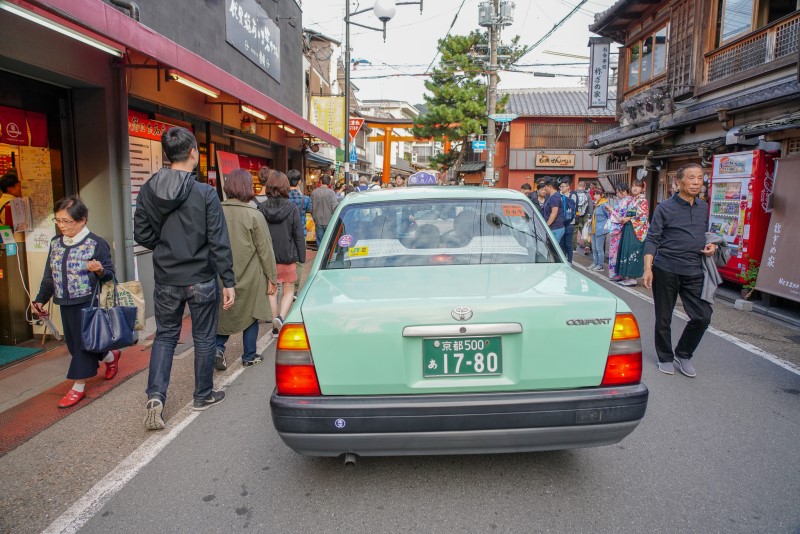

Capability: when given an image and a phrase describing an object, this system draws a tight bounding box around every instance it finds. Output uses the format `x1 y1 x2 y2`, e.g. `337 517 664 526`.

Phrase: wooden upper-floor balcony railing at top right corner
705 13 800 83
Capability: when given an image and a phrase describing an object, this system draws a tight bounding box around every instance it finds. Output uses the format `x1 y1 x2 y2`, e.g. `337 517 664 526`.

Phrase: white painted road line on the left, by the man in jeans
42 340 273 534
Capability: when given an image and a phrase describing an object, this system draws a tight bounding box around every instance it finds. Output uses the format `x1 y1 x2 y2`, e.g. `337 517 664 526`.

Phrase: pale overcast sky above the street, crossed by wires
302 0 616 104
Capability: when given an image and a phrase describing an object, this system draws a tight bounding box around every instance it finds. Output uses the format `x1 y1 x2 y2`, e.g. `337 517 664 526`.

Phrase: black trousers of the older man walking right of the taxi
653 267 712 362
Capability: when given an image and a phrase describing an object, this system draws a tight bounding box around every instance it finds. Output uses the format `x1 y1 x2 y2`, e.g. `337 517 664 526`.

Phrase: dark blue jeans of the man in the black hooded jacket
147 278 219 402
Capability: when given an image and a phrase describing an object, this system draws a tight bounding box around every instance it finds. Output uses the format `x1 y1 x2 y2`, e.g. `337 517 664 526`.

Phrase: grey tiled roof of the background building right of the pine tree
499 87 617 118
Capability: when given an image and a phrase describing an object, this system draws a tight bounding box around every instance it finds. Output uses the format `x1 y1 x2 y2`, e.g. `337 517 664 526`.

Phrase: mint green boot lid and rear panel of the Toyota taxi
287 263 628 395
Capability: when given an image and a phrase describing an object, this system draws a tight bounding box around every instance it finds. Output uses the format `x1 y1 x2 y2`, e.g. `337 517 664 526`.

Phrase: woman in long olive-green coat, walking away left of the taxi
214 169 277 371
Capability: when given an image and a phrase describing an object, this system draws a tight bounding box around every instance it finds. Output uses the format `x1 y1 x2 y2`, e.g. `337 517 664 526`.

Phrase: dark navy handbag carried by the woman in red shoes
81 277 136 352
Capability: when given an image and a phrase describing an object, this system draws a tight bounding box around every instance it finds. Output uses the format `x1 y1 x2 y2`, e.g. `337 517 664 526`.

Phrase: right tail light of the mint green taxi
600 313 642 386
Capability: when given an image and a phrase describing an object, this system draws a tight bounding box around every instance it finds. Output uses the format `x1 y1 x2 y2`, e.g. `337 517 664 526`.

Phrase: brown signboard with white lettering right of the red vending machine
756 158 800 302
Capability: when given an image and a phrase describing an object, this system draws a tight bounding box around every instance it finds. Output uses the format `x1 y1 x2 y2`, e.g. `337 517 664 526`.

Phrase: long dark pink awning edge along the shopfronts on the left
27 0 341 148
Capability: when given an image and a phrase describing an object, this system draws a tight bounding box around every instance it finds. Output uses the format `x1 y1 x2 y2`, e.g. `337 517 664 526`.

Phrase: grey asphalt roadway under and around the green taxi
70 276 800 534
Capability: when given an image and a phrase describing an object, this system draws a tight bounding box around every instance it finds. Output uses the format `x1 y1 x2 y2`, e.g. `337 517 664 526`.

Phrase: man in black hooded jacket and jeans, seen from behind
134 127 235 430
